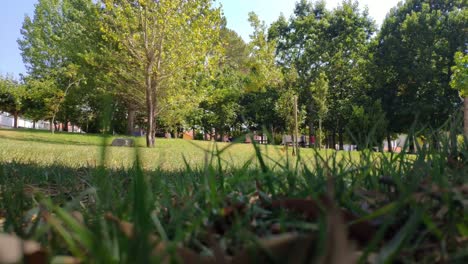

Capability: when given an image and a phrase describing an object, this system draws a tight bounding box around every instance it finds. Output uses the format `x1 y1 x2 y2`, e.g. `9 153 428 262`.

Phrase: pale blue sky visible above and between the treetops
0 0 399 76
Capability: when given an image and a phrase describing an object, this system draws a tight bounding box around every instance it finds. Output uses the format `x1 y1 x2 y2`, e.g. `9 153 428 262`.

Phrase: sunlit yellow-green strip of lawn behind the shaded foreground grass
0 130 359 171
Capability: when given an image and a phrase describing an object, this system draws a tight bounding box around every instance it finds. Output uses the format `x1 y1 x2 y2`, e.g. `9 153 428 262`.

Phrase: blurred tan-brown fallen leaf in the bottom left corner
0 234 47 264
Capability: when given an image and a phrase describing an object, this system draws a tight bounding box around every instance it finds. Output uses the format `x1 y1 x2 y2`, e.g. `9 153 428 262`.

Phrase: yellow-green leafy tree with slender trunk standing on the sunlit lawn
103 0 221 147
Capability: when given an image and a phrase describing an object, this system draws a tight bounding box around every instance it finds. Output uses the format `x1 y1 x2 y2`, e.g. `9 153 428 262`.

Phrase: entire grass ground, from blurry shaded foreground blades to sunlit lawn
0 127 468 263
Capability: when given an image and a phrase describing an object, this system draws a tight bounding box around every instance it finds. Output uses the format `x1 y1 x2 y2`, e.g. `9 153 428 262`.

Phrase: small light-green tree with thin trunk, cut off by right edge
450 52 468 138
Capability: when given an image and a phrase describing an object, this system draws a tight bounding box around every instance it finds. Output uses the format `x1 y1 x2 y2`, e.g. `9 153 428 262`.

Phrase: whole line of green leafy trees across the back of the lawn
0 0 468 149
